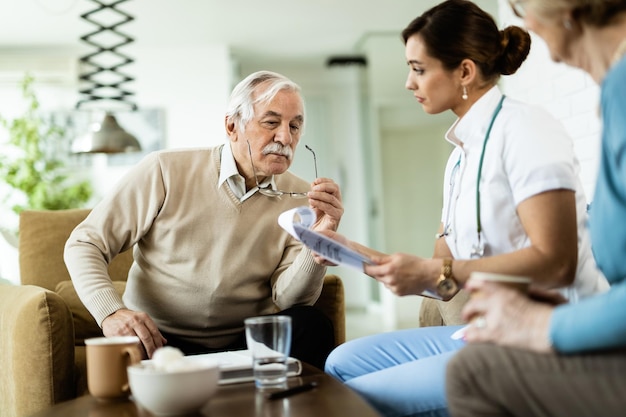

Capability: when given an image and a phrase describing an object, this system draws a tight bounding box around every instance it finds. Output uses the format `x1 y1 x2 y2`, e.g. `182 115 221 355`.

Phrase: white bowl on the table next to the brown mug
128 358 220 416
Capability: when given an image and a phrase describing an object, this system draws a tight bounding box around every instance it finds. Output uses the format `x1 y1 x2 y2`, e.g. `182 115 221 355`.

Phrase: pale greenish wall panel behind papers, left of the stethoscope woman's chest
382 122 452 327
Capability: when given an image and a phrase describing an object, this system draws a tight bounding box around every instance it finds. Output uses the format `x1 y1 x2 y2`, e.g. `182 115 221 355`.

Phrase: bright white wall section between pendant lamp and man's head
134 45 232 148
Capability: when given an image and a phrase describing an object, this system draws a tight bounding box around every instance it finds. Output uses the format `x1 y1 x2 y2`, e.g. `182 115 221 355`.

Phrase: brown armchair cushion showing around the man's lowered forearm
55 280 126 346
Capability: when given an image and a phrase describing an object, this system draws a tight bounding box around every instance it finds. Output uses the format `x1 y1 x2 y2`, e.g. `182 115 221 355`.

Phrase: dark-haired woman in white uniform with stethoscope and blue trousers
325 0 606 416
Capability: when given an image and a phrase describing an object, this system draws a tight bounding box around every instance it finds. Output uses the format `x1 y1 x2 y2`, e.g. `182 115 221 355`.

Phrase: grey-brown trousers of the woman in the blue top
446 344 626 417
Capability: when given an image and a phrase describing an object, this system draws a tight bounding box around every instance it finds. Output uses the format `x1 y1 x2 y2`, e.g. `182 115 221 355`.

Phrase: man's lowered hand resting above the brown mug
102 309 167 358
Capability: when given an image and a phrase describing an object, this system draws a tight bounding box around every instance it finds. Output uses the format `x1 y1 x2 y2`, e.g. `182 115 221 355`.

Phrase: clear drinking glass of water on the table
244 316 291 388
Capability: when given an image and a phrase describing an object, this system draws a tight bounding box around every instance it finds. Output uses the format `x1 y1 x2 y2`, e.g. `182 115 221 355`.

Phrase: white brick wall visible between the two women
500 1 601 201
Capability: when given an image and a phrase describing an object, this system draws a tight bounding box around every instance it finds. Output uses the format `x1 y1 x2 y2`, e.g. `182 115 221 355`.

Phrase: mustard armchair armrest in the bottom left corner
0 285 75 417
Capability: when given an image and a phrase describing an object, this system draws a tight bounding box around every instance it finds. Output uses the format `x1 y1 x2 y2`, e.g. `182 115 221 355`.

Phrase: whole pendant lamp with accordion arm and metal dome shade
71 0 141 154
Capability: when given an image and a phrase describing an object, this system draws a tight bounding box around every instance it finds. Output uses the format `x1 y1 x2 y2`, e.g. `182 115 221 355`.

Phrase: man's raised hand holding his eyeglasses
309 178 343 232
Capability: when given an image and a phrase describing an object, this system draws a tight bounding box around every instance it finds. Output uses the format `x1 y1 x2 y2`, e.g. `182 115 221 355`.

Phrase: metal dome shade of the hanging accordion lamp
72 113 141 153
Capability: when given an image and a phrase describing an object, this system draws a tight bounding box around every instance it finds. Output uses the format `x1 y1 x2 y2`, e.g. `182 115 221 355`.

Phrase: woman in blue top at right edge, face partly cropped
447 0 626 417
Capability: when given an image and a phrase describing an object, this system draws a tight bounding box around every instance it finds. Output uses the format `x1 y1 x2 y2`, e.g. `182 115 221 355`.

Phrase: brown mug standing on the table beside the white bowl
85 336 141 400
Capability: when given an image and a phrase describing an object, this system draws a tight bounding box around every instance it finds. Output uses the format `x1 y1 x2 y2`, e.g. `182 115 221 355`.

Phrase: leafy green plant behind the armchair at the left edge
0 75 93 244
